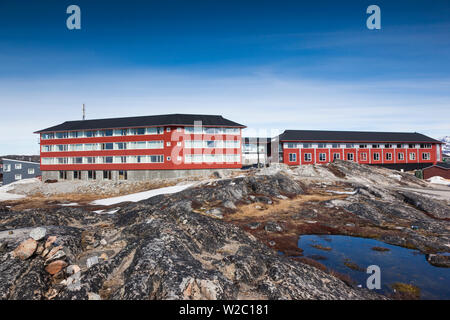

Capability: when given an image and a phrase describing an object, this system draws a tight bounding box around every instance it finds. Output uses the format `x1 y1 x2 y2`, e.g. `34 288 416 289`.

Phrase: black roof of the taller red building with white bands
35 113 245 133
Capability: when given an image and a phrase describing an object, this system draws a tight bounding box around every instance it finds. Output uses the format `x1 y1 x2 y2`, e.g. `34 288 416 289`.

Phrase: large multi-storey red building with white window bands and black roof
35 114 245 181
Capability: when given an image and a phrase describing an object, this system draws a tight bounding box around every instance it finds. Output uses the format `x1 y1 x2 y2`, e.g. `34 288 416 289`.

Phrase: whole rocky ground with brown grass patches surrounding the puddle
0 161 450 299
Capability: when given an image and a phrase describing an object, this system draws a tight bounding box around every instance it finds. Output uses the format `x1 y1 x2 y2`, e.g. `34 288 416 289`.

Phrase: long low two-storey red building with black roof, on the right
279 130 442 169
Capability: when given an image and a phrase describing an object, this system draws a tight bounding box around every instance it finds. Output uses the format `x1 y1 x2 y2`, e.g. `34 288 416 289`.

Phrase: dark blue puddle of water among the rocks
298 235 450 299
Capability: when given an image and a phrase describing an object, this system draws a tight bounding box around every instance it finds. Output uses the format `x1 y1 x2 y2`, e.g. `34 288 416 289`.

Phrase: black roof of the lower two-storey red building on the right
279 130 442 143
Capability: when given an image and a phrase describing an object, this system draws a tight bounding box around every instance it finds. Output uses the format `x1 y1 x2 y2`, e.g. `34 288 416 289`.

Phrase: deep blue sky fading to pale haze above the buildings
0 0 450 154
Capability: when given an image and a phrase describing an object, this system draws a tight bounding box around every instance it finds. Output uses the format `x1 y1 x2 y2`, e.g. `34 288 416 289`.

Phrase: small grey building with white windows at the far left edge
2 158 41 185
